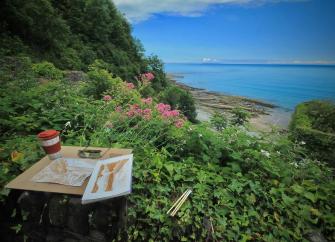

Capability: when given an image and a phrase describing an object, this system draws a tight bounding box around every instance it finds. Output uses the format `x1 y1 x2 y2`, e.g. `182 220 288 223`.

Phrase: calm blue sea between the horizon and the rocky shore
165 64 335 110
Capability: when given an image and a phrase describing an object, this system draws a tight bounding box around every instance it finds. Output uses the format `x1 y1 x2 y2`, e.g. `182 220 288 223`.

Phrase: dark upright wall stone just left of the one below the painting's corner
49 195 68 226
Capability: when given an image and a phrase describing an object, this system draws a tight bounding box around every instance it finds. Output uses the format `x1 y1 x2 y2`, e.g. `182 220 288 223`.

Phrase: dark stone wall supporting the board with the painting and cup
18 192 127 242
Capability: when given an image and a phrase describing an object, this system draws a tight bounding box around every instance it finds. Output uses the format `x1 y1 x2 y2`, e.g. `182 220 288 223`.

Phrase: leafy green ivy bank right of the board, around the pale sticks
128 128 335 241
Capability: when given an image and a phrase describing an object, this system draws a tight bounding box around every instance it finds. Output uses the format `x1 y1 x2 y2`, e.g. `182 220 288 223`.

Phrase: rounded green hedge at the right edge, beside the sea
290 101 335 166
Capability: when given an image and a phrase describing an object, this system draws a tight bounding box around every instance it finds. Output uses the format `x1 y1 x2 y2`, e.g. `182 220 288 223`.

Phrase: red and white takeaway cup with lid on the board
37 129 62 160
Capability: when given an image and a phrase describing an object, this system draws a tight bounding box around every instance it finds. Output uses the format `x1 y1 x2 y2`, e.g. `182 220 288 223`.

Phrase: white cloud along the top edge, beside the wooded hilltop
113 0 305 22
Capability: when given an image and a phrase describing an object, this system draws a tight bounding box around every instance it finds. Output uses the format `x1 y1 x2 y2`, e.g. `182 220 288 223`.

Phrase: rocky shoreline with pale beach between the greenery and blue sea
167 73 291 132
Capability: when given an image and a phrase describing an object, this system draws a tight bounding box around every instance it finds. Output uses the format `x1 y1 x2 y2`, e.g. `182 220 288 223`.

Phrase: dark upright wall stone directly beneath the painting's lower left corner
67 198 89 235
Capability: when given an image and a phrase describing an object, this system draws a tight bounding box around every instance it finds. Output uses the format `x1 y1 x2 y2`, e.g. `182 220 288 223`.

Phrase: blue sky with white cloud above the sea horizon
114 0 335 64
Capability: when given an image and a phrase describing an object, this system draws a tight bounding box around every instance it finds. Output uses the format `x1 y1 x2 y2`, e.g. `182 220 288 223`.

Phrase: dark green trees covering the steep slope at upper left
0 0 146 81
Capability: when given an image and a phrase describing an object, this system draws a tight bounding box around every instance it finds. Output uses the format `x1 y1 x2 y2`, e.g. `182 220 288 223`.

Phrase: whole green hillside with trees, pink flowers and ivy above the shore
0 0 335 241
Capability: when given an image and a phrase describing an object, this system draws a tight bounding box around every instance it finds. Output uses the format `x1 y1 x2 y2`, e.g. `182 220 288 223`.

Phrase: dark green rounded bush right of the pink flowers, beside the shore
160 85 197 122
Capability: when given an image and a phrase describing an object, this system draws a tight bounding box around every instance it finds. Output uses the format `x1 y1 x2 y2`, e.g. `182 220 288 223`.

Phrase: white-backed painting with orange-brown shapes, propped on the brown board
82 155 133 204
